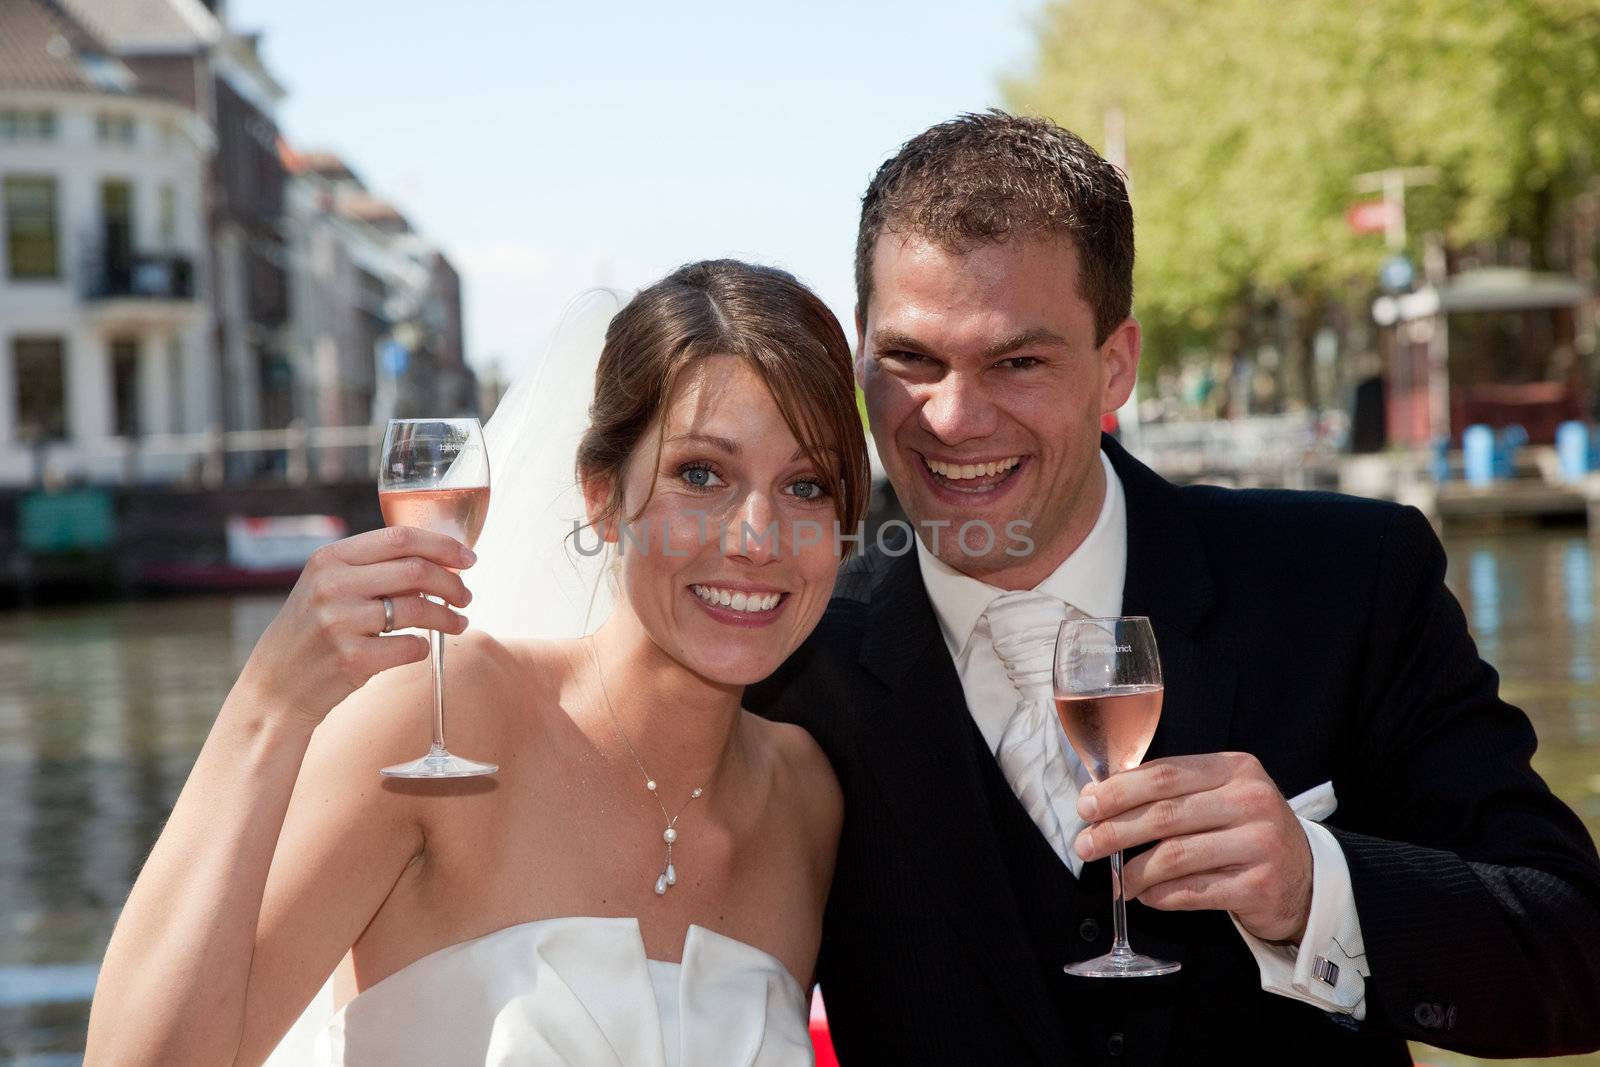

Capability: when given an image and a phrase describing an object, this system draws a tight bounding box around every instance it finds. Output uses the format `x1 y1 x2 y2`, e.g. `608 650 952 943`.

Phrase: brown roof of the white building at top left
0 0 139 93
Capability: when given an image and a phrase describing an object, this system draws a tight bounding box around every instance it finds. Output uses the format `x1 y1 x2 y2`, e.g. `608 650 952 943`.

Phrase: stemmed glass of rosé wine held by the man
1051 616 1179 977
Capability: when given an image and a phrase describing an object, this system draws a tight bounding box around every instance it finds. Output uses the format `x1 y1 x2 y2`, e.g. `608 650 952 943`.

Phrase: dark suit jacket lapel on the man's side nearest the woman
861 552 1066 1062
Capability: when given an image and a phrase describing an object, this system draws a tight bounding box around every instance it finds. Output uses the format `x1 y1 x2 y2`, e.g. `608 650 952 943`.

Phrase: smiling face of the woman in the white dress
606 355 840 685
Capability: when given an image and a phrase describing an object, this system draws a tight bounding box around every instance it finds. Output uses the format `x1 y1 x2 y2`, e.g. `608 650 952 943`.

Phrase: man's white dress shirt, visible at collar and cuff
915 453 1370 1019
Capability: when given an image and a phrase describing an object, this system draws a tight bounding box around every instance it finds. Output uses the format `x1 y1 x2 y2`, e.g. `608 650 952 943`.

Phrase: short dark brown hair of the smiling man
856 110 1133 344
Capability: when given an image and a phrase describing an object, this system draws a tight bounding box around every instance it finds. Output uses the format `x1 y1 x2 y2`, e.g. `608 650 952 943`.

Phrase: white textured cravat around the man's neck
984 590 1083 873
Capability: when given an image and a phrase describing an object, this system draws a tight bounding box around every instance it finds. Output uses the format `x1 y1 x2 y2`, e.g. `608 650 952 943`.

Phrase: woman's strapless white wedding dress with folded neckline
267 917 813 1067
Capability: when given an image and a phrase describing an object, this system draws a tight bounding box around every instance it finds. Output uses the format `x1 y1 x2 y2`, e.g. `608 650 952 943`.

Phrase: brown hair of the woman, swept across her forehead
578 259 872 556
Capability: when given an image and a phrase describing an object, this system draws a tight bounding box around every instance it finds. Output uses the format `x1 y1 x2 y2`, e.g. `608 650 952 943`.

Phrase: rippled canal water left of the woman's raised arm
0 597 280 1062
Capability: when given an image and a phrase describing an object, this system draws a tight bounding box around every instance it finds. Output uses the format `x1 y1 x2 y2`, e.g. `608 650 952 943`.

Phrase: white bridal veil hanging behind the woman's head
462 290 629 638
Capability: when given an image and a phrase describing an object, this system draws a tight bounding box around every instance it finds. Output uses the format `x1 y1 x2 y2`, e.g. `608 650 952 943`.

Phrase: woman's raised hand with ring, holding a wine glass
235 526 475 726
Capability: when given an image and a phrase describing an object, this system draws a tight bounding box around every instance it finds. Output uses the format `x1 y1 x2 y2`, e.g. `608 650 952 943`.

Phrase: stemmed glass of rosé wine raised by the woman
378 419 499 777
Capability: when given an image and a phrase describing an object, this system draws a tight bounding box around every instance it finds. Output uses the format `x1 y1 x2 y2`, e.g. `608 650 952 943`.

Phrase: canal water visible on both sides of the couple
0 530 1600 1067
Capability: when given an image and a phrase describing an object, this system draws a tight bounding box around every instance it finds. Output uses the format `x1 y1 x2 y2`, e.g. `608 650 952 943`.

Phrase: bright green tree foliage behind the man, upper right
1005 0 1600 375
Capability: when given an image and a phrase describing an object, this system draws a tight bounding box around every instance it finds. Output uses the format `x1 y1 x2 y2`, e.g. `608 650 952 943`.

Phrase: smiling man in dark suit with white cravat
747 112 1600 1065
